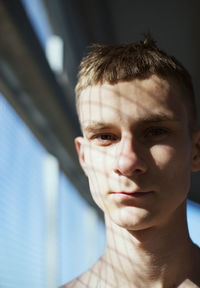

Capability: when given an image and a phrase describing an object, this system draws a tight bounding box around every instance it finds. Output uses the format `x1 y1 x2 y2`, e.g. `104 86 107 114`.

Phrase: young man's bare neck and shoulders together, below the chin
63 210 200 288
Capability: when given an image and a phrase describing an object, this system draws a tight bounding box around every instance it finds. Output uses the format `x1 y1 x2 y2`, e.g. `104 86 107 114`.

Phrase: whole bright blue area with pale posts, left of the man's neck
0 94 105 288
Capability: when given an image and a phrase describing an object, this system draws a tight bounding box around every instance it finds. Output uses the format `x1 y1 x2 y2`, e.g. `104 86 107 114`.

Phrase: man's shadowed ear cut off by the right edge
192 129 200 172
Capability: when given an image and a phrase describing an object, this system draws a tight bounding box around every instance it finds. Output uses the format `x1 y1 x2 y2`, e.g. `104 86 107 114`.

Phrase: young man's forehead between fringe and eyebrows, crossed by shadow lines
79 76 186 127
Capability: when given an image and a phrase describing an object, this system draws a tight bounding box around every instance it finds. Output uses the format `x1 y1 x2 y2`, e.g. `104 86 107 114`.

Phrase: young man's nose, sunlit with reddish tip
114 137 147 177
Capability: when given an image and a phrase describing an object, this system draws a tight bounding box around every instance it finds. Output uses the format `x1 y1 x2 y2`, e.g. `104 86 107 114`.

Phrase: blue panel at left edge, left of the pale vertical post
0 95 46 287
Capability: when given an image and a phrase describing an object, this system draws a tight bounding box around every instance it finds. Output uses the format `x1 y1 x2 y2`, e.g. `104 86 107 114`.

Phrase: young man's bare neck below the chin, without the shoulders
98 202 196 287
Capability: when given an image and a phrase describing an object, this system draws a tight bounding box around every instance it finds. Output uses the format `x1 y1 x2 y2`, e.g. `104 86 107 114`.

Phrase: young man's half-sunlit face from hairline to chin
76 76 199 230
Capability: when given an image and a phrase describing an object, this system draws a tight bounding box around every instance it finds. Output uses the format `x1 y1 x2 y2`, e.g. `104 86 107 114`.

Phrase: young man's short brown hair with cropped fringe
75 35 197 128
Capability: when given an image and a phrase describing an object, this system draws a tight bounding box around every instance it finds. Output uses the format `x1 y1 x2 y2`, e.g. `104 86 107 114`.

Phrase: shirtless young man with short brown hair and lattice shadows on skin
63 38 200 288
